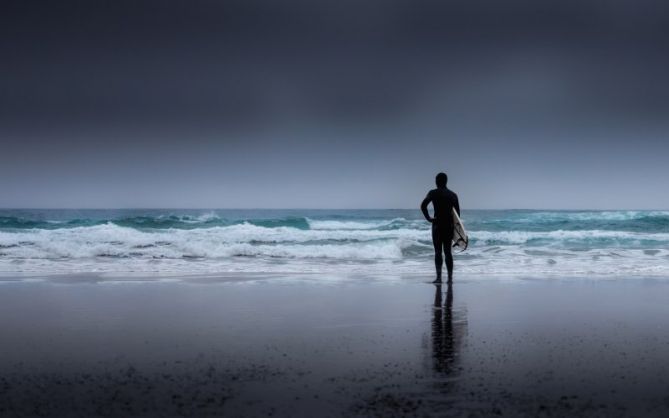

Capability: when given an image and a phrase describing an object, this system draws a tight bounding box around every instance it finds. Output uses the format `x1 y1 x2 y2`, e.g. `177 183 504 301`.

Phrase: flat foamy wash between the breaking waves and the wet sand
0 247 669 279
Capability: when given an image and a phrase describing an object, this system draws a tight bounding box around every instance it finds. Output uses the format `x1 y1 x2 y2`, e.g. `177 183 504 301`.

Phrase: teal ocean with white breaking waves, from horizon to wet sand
0 209 669 278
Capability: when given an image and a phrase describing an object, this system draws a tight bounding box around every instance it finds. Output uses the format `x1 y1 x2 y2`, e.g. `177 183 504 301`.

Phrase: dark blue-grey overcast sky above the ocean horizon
0 0 669 209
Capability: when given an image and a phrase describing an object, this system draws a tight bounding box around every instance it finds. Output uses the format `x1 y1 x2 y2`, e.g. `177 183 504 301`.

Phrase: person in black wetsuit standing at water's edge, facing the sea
420 173 460 283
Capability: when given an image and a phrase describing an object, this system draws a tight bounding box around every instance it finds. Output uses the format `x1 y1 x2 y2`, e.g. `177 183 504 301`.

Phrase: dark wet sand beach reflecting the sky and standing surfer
0 275 669 417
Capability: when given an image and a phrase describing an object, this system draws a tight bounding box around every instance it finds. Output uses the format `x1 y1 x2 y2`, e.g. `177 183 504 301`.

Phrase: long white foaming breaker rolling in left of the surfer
0 223 426 259
